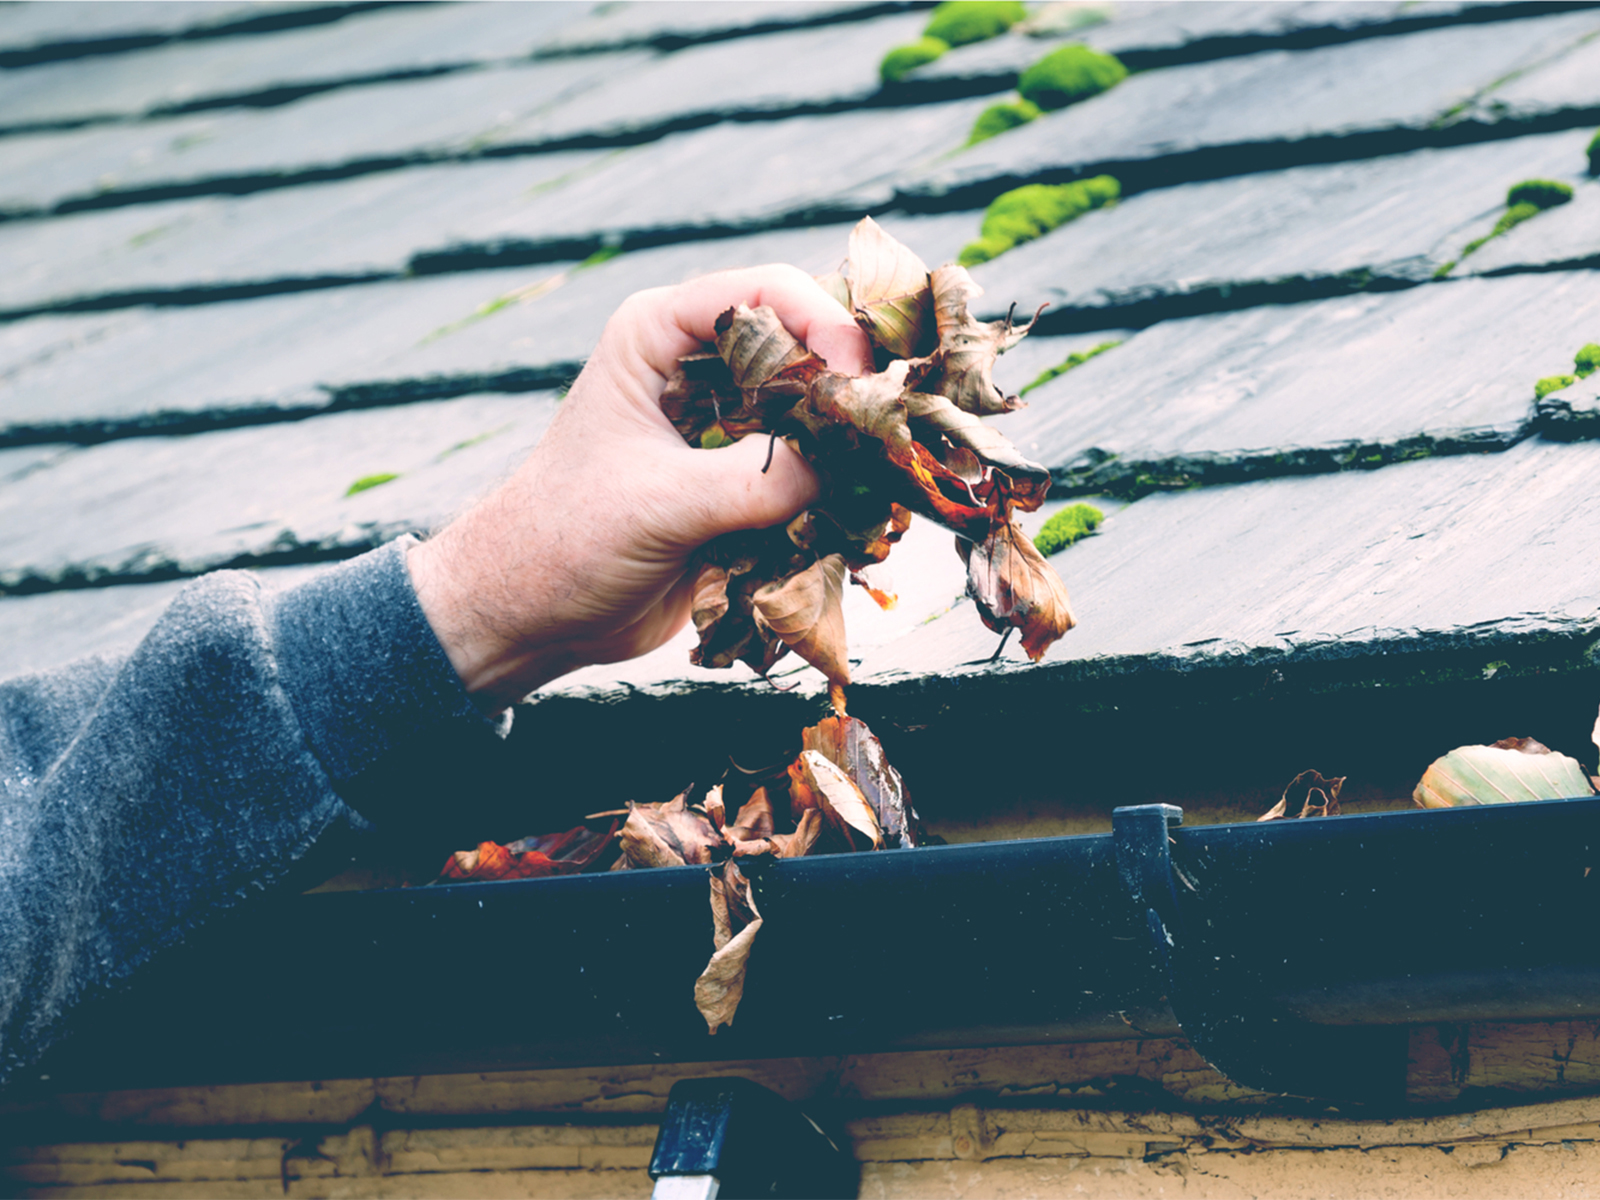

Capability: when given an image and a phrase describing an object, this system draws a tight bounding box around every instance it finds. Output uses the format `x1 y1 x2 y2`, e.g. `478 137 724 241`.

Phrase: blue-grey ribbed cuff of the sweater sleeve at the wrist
267 538 489 787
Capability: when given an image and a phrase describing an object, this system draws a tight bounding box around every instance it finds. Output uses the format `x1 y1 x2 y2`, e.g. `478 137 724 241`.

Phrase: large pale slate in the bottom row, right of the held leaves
858 440 1600 686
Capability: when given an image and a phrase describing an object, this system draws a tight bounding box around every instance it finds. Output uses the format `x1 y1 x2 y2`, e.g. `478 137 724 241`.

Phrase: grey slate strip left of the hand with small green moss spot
0 394 555 592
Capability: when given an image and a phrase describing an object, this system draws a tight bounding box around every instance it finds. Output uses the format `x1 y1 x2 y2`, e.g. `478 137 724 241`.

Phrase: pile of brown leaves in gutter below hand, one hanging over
440 715 923 1034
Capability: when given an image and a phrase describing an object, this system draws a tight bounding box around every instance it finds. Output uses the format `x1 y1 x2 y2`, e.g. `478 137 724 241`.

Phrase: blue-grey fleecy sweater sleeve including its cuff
0 539 488 1078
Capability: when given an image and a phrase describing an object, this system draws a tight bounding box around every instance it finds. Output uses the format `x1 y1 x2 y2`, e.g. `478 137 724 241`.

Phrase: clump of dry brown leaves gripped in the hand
661 218 1074 709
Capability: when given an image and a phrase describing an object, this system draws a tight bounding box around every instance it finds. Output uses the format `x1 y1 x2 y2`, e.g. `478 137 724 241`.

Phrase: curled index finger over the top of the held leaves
640 264 872 376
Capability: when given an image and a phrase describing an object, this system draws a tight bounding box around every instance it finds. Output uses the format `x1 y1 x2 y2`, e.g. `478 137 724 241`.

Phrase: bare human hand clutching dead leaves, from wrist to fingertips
408 266 872 709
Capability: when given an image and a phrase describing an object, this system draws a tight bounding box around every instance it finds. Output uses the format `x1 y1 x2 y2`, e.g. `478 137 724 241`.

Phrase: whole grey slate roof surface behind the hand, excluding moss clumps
0 2 1600 761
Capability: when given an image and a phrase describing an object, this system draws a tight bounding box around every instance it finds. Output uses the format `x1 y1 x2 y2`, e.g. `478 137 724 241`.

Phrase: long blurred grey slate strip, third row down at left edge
0 5 923 214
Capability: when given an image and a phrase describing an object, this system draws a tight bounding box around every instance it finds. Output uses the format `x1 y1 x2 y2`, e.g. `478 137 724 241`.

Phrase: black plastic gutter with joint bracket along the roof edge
13 798 1600 1102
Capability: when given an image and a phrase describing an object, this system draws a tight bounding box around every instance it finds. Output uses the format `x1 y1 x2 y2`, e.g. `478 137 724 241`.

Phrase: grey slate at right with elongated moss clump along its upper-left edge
973 131 1600 325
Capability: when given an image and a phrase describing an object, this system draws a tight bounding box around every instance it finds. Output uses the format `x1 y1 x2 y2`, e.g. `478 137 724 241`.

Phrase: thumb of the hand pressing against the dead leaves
685 434 821 544
